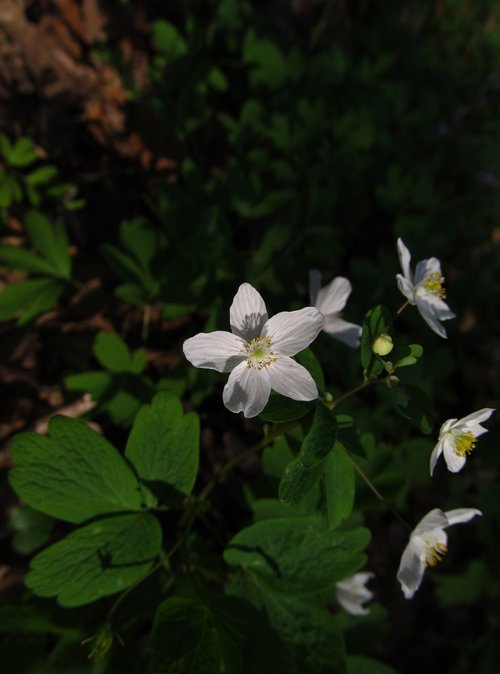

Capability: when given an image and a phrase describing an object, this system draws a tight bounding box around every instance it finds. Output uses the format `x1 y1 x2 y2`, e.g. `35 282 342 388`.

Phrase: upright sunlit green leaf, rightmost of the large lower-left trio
125 393 200 505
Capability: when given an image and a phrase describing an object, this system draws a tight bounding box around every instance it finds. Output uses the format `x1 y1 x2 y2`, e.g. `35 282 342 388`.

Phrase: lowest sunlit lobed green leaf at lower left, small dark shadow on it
25 513 162 606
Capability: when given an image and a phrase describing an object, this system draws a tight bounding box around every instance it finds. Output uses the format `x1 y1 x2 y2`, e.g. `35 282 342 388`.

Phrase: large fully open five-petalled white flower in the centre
183 283 323 417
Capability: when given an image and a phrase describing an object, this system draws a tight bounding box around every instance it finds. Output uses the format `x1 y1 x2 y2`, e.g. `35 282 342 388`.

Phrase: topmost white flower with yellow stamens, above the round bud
396 239 455 339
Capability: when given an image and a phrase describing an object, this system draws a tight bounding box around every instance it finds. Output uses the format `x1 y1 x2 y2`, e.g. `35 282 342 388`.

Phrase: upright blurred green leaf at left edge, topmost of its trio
24 211 71 279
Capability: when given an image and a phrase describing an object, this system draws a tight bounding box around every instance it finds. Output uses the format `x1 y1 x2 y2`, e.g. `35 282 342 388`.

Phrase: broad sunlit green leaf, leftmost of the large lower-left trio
9 416 141 523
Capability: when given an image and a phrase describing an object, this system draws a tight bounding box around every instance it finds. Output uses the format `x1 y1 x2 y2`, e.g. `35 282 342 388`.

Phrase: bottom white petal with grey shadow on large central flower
222 362 271 418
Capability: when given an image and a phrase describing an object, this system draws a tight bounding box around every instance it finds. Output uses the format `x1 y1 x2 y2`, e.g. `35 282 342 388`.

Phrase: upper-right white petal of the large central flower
262 307 323 356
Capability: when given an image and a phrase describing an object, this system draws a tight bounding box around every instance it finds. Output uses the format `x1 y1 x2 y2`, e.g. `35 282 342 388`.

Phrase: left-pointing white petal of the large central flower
182 330 245 372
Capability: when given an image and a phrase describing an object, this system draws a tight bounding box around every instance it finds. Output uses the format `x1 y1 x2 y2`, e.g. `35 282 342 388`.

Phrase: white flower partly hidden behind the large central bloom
309 269 361 349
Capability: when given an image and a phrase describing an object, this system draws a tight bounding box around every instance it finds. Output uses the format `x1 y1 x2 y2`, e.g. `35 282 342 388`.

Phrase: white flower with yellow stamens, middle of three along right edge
430 407 495 475
